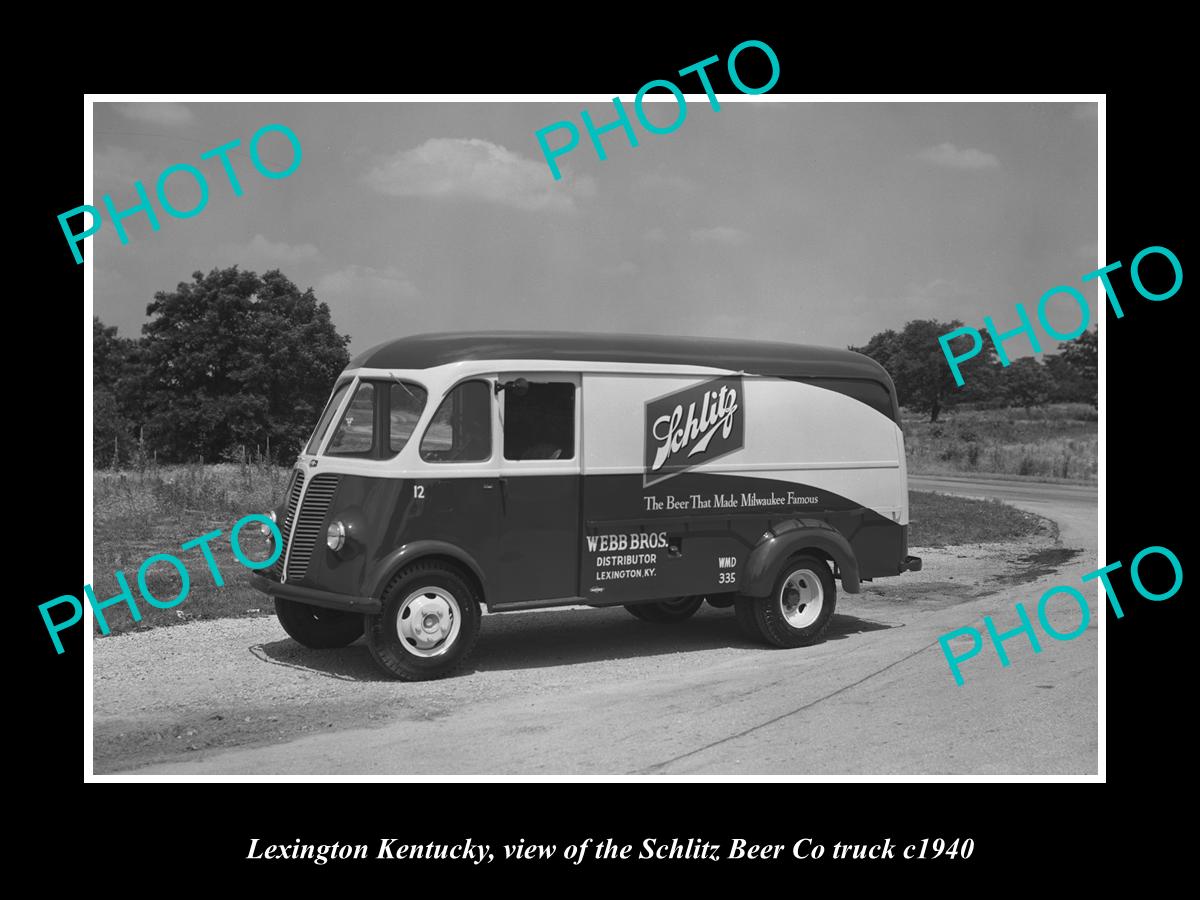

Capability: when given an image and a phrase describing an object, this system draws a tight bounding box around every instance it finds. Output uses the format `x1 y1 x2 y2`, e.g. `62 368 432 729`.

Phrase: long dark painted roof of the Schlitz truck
348 331 892 389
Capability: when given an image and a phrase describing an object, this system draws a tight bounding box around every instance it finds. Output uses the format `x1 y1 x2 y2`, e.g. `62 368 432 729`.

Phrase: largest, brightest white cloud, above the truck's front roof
366 138 595 212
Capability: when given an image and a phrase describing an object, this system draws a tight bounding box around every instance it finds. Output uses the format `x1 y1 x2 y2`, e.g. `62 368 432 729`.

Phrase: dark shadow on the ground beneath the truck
250 610 895 682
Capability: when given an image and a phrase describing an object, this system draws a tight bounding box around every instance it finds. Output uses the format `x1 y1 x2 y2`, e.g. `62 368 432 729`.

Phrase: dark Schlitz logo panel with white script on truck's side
642 376 745 487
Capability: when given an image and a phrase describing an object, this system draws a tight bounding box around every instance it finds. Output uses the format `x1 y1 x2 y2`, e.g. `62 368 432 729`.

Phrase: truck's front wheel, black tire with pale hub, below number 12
364 563 480 682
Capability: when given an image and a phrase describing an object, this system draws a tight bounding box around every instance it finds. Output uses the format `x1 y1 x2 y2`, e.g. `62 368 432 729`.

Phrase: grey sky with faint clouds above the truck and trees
91 101 1103 358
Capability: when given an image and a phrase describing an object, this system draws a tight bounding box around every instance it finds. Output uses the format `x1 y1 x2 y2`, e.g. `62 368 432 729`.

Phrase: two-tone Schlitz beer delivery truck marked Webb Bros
251 332 920 680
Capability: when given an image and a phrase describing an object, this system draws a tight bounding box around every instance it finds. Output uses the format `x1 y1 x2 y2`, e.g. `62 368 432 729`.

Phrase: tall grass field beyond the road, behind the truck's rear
904 403 1098 484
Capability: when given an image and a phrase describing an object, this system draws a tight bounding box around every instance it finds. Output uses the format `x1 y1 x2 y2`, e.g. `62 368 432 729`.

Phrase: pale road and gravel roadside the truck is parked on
103 478 1098 775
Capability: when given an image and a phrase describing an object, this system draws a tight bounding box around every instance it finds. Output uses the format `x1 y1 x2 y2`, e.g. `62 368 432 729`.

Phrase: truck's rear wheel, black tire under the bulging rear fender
736 556 838 647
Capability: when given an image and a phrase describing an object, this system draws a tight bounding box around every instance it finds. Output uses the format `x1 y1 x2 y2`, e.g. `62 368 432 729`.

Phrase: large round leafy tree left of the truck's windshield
142 266 350 461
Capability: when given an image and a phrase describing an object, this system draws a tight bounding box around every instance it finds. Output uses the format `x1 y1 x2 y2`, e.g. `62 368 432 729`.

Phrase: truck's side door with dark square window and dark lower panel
489 372 581 605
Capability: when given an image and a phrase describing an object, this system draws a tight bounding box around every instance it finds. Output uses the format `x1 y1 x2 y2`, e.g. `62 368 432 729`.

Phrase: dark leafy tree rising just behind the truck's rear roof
850 319 997 422
